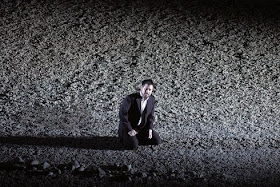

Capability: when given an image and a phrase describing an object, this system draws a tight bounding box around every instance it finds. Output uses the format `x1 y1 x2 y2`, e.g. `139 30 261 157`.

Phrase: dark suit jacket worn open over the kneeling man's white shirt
119 93 155 131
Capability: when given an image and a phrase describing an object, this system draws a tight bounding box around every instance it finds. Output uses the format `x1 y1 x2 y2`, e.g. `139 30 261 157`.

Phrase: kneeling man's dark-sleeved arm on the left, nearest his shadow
119 96 132 131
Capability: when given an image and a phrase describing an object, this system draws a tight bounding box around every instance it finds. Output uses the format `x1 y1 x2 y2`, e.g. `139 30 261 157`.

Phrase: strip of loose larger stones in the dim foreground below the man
1 157 190 181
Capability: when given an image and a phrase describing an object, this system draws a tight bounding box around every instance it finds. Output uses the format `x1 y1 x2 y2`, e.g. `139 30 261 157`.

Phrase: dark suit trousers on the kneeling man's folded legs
119 129 162 150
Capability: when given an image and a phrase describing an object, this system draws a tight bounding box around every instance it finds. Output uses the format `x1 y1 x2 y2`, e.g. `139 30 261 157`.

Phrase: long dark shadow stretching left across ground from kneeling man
0 136 122 150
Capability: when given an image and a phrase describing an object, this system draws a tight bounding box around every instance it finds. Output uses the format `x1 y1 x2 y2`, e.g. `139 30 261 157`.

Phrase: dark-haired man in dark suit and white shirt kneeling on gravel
118 79 162 149
